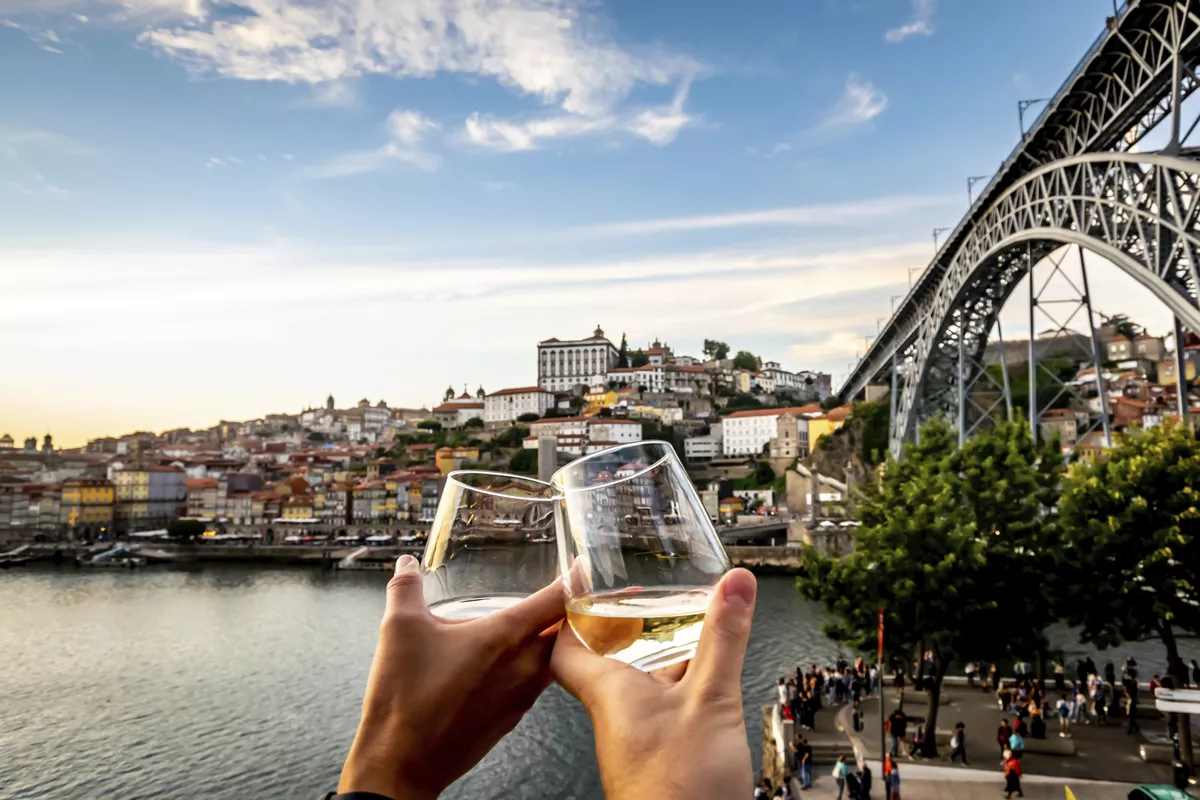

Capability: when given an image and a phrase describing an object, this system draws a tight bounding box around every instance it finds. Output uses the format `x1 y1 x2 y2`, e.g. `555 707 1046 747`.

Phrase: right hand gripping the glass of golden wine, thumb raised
551 570 757 800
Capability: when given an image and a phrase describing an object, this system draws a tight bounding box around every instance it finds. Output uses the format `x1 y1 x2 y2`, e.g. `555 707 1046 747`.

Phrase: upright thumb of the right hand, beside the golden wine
684 570 758 697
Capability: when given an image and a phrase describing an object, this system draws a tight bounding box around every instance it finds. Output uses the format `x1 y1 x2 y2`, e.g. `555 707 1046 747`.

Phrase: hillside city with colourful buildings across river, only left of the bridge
0 327 850 543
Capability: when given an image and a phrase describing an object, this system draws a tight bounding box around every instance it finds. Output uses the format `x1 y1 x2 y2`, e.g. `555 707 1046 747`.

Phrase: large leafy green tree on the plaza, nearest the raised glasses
798 421 1061 756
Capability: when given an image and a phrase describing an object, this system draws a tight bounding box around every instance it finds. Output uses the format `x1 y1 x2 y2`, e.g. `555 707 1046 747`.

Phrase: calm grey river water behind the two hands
0 567 1190 800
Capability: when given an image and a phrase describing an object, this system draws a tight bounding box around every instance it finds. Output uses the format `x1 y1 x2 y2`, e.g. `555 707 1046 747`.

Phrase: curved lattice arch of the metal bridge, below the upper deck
892 154 1200 455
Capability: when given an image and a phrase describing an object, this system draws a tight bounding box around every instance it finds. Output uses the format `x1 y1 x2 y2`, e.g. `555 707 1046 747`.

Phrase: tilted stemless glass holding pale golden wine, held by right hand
551 441 730 672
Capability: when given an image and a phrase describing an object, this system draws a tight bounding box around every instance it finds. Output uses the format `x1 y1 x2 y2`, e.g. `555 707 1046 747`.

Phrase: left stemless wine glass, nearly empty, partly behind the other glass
421 470 558 619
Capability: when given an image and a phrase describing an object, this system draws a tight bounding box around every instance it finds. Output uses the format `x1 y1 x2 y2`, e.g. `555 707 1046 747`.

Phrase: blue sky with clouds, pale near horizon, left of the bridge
0 0 1161 444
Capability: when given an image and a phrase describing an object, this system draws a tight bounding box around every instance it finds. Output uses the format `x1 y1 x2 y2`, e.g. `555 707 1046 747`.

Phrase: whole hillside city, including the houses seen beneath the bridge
0 318 1200 551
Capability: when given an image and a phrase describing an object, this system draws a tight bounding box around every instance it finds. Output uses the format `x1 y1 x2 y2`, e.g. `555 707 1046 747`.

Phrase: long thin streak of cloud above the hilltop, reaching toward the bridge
575 194 956 236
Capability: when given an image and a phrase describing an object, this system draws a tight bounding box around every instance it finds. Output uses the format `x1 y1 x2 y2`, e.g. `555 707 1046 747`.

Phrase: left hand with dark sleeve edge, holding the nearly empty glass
338 555 565 800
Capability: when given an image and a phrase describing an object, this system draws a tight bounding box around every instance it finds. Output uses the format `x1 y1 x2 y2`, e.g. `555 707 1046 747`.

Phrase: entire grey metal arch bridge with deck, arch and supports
838 0 1200 456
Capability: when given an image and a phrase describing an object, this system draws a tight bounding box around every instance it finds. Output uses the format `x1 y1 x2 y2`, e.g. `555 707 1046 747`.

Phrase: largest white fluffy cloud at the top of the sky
139 0 697 115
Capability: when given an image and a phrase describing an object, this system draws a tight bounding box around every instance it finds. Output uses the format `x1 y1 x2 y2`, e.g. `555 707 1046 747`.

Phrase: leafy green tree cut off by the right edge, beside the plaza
1056 426 1200 764
